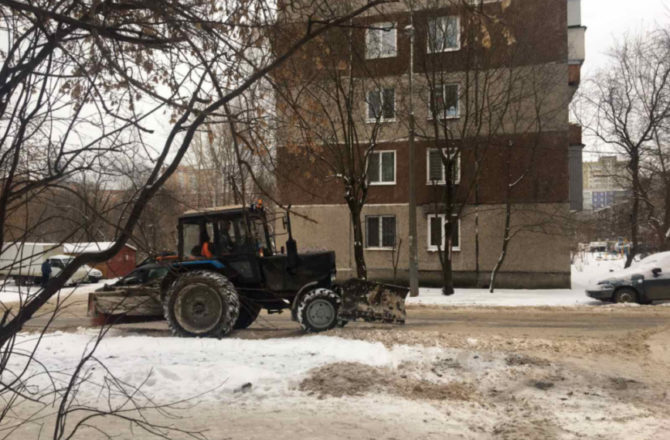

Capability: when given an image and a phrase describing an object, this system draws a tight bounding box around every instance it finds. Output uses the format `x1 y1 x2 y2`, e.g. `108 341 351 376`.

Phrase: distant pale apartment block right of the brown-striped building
582 156 630 211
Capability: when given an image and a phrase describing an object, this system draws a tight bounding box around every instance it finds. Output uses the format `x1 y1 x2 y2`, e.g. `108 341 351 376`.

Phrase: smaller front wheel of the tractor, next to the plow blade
297 288 341 333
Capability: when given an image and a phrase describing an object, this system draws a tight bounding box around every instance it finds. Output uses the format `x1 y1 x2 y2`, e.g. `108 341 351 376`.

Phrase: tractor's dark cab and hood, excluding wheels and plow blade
175 201 335 300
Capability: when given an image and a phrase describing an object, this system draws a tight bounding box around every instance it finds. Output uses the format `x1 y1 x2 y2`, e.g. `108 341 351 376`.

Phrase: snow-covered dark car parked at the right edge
586 252 670 304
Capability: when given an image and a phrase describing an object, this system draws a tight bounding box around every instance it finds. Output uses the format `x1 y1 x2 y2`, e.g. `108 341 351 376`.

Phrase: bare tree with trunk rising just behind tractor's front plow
275 15 398 279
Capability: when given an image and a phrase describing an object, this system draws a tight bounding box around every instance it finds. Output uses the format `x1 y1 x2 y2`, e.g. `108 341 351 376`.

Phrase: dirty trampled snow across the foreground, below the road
10 330 670 440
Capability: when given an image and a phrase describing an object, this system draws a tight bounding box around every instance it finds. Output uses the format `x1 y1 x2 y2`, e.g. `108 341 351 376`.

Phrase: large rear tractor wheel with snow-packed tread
163 270 240 338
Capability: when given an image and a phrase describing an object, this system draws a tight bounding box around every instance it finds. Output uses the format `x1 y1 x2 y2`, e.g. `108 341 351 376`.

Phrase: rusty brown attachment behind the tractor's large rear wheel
88 286 163 318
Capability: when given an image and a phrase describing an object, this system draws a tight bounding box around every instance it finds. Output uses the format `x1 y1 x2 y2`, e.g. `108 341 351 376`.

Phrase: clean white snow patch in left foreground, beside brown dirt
9 330 440 402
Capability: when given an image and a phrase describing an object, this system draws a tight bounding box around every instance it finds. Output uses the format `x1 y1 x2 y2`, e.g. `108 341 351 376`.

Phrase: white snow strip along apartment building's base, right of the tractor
407 254 636 307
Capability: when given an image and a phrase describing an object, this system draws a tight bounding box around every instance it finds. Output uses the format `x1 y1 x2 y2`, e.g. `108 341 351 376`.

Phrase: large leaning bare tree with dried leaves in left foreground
0 0 392 438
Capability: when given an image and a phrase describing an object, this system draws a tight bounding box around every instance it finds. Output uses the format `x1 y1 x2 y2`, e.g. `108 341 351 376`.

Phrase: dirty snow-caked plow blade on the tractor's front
338 279 409 324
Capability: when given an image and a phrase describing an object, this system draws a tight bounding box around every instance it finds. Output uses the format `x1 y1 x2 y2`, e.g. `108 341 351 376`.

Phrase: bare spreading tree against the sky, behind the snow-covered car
577 29 670 267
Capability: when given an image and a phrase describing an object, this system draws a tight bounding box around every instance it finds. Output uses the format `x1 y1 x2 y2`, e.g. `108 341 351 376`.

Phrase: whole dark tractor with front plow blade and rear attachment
89 203 407 337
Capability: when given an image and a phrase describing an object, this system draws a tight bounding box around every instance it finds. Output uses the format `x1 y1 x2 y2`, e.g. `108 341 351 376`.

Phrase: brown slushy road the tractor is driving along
14 295 670 338
